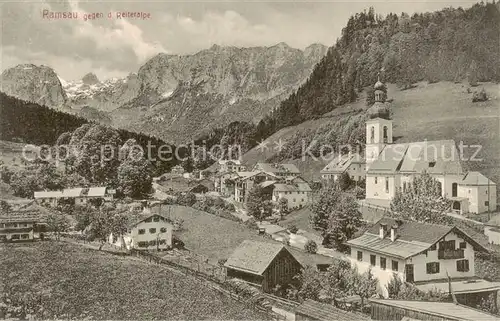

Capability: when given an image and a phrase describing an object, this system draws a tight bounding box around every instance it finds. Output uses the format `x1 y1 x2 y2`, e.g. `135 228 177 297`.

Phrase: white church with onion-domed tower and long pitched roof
358 80 497 214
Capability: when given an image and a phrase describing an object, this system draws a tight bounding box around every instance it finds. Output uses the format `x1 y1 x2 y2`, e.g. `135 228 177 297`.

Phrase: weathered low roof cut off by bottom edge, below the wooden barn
295 299 370 321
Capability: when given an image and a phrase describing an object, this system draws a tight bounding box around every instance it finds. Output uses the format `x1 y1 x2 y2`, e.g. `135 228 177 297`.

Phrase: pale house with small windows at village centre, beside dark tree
270 176 312 209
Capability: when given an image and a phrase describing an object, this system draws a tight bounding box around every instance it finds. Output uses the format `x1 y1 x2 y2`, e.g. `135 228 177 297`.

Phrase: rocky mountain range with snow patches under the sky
1 43 327 143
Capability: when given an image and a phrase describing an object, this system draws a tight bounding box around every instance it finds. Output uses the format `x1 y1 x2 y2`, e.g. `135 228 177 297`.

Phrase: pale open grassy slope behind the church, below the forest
243 82 500 183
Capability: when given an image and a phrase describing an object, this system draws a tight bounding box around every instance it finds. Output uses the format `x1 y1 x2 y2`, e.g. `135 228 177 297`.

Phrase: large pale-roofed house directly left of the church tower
320 153 366 182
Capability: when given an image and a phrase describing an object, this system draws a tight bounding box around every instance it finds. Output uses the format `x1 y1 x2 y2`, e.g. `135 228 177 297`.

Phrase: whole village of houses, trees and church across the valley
0 80 500 320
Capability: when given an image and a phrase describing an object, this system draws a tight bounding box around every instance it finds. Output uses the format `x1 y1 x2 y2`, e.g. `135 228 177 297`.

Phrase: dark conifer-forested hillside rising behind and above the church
198 2 500 159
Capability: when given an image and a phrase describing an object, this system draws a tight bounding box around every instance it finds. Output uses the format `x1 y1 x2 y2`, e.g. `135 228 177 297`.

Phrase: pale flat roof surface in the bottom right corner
370 299 500 321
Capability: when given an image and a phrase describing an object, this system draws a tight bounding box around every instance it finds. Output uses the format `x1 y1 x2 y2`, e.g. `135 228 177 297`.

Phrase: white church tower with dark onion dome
365 79 392 169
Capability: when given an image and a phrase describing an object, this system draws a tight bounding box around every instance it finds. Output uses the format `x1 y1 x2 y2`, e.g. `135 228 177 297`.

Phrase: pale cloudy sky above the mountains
0 0 482 80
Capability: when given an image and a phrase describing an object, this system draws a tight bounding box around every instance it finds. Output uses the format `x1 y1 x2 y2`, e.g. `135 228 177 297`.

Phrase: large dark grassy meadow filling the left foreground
0 242 265 320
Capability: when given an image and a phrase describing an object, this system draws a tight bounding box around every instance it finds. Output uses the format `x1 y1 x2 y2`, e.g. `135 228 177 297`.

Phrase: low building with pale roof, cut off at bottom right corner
370 299 500 321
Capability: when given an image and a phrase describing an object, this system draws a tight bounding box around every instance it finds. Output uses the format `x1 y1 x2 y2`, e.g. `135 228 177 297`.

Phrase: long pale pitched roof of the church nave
368 140 463 174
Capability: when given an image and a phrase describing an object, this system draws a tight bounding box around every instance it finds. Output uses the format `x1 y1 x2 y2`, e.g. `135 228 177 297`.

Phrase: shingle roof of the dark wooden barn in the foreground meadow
224 240 292 275
